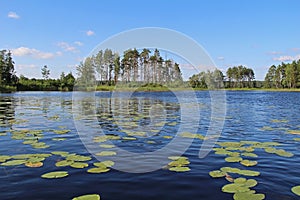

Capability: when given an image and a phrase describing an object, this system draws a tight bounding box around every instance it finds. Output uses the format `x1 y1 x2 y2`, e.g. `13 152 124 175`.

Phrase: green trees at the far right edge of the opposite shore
264 59 300 88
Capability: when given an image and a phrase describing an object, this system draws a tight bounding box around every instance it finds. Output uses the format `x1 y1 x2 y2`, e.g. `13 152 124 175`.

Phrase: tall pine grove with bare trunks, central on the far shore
77 49 183 86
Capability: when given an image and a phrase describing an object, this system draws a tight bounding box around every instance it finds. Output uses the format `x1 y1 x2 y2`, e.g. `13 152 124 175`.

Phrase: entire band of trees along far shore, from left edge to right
0 48 300 92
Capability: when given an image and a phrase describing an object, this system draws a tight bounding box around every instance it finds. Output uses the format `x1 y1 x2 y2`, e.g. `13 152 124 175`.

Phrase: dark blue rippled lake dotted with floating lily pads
0 91 300 200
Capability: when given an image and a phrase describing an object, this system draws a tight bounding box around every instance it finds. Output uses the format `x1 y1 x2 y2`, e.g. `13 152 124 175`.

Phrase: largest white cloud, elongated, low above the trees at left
12 47 56 59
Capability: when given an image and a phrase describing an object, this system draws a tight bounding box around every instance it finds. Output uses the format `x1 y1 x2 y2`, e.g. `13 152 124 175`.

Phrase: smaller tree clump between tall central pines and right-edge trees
189 65 263 89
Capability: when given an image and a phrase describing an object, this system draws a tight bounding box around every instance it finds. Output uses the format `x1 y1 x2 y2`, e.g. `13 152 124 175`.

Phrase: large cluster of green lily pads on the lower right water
209 141 300 200
